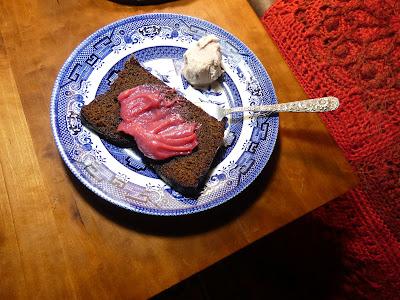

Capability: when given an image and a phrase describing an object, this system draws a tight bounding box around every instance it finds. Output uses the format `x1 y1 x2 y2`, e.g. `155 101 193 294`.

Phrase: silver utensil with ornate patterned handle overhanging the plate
193 96 339 121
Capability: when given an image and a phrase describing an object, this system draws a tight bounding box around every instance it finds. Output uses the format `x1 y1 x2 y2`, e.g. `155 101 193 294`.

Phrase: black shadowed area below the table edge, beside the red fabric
152 210 355 300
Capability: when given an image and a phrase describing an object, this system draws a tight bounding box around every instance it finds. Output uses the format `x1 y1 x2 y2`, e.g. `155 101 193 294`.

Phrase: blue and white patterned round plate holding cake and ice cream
50 14 278 215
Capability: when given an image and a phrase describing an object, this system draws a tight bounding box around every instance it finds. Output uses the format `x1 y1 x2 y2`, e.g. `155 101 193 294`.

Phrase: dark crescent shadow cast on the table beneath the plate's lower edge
65 138 280 236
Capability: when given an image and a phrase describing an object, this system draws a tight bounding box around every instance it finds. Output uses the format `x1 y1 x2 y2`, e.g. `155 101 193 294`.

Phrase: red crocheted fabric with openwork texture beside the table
262 0 400 299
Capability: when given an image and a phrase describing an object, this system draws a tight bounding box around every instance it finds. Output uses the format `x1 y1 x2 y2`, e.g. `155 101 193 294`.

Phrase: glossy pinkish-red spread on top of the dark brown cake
118 85 199 160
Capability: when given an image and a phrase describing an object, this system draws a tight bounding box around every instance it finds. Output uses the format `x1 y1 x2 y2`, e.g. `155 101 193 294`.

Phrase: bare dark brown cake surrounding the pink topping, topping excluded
81 57 225 195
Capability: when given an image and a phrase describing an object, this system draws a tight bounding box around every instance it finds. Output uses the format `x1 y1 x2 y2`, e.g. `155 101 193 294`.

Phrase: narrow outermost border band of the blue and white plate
50 13 279 216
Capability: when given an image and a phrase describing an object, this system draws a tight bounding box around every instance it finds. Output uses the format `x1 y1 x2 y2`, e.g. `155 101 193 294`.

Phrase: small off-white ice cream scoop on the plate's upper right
182 35 224 86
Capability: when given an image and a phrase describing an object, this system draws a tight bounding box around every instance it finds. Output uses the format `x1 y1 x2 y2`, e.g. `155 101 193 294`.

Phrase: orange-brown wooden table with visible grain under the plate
0 0 356 299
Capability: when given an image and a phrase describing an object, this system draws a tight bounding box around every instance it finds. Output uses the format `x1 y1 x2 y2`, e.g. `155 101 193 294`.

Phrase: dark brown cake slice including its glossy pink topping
81 57 225 196
